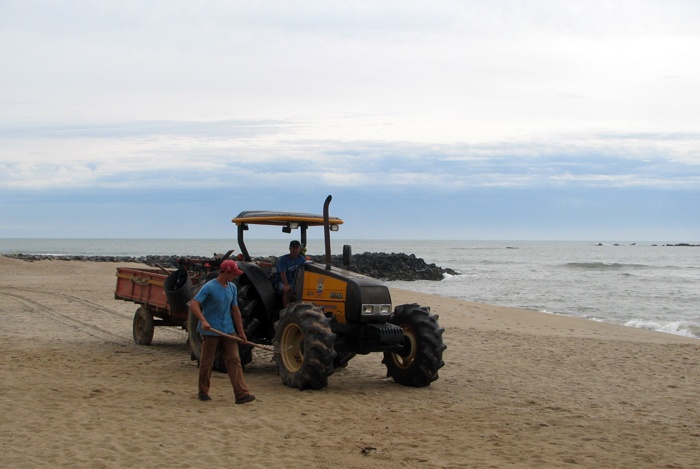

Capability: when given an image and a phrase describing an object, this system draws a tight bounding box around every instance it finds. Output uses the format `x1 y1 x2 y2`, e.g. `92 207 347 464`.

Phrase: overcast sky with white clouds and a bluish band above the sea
0 0 700 242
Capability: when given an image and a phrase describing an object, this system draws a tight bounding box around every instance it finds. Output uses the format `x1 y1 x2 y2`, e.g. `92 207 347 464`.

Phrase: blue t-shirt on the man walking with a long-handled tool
194 280 238 335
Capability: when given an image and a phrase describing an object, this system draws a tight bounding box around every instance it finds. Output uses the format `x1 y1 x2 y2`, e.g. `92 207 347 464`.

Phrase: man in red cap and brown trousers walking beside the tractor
189 260 255 404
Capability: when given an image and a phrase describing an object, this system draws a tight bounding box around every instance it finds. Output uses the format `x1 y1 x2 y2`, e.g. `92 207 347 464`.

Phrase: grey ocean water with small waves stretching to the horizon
0 238 700 338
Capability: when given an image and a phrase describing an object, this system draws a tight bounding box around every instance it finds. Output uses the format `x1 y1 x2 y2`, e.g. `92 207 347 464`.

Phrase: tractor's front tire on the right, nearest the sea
382 304 447 388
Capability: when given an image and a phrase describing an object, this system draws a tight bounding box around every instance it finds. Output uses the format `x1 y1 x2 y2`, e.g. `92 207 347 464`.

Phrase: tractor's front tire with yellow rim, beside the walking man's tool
274 303 336 391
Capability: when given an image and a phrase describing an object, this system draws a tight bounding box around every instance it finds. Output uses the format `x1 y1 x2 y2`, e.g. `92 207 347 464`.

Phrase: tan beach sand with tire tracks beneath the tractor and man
0 257 700 468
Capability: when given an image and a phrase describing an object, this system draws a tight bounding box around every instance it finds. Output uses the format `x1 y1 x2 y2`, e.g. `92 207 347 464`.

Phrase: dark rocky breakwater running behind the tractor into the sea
4 252 459 281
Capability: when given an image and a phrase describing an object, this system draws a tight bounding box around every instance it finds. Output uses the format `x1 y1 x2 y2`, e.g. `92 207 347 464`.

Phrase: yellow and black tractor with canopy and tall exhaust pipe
189 196 446 390
